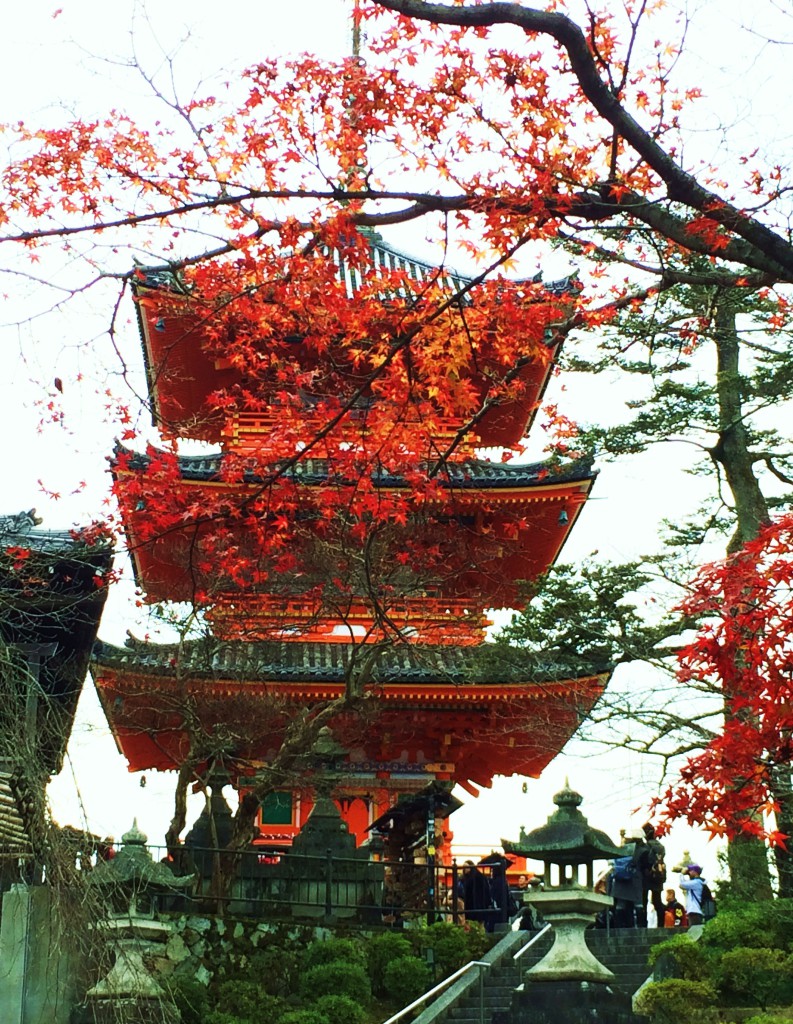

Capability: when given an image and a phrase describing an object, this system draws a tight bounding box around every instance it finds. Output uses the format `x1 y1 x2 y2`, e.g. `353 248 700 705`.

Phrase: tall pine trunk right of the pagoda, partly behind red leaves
711 290 773 899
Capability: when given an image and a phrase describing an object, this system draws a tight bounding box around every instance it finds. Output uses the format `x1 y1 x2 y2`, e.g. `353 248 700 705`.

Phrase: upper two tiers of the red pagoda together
113 233 594 645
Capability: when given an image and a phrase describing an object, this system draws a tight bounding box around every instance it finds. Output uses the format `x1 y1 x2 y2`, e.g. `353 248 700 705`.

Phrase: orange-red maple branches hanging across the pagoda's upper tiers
0 0 793 880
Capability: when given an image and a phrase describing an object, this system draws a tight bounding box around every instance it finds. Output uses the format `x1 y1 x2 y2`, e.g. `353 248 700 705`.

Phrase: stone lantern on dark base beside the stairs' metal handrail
503 781 624 983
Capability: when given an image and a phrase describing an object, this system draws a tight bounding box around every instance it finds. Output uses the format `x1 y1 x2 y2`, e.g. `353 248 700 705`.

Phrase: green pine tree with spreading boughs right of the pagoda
507 276 791 887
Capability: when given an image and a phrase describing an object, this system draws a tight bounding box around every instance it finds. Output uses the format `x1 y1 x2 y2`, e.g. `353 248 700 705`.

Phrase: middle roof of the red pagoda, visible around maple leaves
114 446 597 614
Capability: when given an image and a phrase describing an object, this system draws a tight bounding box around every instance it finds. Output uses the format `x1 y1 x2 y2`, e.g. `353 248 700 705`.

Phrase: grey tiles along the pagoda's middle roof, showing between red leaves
116 444 597 489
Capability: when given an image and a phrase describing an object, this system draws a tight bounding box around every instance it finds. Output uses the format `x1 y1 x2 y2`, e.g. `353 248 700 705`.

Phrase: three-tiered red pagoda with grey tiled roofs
92 234 608 856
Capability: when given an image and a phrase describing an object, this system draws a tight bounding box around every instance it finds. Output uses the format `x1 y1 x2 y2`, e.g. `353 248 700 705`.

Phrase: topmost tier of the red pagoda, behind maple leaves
135 237 576 457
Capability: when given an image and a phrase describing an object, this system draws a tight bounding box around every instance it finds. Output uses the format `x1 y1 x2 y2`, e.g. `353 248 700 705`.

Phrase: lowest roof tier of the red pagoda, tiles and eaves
91 639 609 839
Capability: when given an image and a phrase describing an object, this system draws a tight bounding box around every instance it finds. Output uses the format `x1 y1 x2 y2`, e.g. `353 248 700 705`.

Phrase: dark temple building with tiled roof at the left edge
0 509 112 864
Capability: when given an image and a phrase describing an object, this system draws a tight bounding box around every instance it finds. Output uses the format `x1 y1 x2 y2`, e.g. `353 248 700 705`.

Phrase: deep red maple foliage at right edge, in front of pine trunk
661 515 793 844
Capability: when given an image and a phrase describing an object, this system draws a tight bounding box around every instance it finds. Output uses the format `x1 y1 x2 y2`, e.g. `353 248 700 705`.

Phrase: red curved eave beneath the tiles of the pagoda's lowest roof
92 643 609 774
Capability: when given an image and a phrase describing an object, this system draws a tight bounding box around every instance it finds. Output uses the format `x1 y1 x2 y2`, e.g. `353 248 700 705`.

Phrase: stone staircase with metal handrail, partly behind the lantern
426 928 669 1024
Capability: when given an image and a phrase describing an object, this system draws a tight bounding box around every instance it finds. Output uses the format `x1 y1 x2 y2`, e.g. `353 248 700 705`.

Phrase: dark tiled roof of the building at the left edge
0 509 113 773
